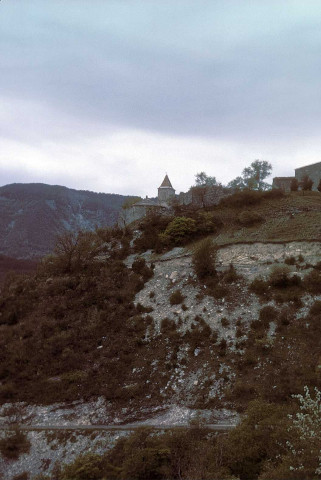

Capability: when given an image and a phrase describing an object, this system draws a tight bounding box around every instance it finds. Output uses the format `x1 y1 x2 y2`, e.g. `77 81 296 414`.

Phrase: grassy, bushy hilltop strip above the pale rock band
135 187 321 253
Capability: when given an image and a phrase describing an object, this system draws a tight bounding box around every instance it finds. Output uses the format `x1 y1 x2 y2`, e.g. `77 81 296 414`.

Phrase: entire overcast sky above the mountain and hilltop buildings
0 0 321 196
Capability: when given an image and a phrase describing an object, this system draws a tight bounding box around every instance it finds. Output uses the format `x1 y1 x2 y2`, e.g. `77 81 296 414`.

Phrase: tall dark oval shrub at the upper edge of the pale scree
192 238 217 280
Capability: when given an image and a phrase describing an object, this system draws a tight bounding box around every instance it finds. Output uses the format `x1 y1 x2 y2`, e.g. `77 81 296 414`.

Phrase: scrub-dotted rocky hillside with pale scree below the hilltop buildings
0 189 321 480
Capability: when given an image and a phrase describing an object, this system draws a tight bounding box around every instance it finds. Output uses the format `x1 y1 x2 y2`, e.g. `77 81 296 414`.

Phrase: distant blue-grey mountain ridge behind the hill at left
0 183 127 258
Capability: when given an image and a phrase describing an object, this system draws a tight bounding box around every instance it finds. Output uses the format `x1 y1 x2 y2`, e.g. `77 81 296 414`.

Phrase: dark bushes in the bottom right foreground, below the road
31 389 321 480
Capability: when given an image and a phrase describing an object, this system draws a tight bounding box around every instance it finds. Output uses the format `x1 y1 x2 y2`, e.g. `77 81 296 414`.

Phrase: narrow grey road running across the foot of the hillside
0 423 236 432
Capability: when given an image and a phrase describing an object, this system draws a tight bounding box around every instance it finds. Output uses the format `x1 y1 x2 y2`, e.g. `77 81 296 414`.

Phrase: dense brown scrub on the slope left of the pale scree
0 230 161 402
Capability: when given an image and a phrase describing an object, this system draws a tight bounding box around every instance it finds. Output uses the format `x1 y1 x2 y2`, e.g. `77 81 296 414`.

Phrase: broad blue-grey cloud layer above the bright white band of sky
0 1 321 152
